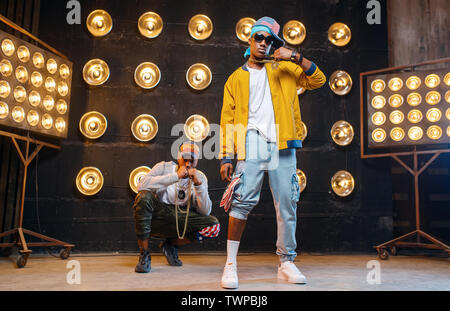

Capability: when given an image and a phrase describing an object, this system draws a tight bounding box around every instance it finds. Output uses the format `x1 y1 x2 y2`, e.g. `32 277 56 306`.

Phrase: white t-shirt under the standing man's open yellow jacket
247 67 277 143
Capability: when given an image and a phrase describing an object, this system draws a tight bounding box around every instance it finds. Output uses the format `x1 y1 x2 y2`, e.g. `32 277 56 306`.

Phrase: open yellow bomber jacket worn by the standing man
219 61 326 163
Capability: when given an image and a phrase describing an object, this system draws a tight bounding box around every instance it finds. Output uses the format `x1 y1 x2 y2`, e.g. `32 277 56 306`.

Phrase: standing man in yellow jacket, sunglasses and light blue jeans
219 17 326 288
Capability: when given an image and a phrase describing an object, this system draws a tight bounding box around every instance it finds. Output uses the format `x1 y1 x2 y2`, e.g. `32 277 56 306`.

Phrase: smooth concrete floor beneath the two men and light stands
0 254 450 291
